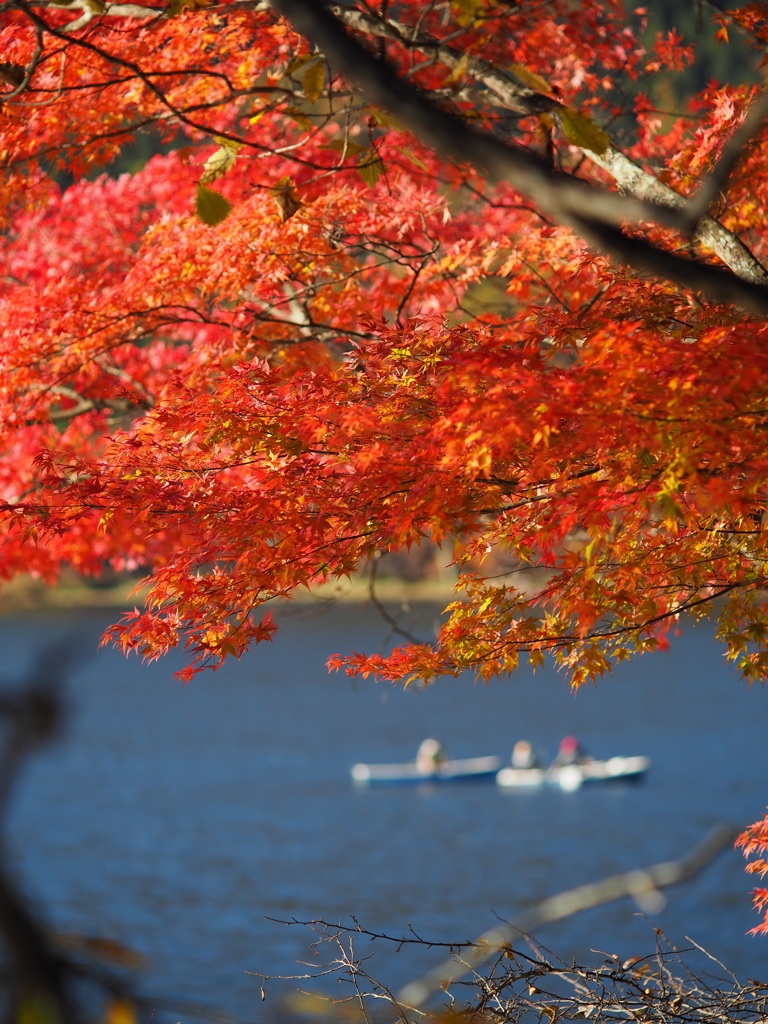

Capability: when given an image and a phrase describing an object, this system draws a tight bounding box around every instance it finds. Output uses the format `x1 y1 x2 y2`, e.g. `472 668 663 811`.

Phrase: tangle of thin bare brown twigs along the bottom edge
261 921 768 1024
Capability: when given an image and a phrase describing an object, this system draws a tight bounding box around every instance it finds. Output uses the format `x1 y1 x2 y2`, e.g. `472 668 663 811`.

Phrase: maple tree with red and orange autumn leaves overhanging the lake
0 0 768 932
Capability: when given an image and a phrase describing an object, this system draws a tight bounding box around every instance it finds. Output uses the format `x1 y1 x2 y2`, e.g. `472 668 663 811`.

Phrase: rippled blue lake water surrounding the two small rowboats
0 606 768 1020
